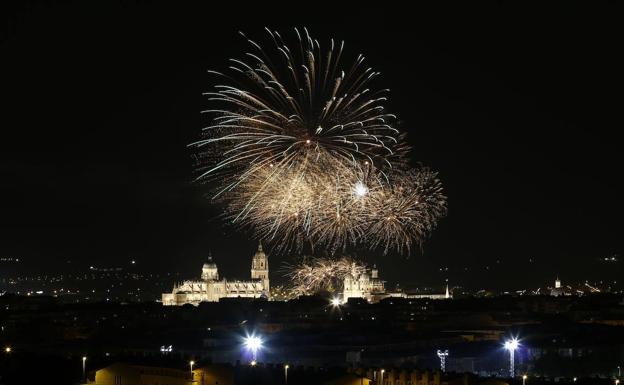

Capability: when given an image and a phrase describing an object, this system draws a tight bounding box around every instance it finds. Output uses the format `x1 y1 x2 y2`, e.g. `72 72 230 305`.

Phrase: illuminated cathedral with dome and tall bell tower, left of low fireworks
162 244 270 306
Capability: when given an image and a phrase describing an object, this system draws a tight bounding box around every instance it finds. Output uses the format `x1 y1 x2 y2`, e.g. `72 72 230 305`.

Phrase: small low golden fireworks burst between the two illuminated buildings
285 257 366 297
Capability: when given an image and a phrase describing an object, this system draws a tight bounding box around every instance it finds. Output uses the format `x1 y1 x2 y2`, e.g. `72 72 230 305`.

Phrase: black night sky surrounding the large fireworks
0 1 624 287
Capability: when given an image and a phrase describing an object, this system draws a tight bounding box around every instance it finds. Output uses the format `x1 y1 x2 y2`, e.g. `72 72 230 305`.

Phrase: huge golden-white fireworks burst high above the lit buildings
192 29 446 254
